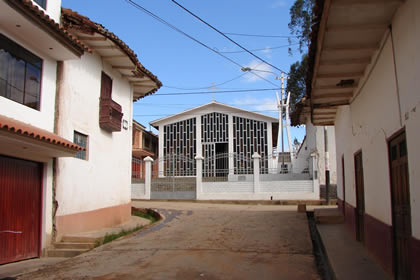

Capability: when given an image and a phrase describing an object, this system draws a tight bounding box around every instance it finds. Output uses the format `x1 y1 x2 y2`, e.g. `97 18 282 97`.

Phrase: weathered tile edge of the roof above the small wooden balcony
61 8 162 96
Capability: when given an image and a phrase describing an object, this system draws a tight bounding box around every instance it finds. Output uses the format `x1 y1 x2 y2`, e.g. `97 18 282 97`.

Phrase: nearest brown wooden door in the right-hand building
389 132 411 279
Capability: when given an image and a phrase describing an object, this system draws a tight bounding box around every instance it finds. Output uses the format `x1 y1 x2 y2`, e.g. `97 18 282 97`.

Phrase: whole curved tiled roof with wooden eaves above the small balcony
61 8 162 100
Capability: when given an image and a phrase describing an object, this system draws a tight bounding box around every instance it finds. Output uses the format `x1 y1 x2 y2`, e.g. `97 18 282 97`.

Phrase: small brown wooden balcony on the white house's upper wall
99 99 123 132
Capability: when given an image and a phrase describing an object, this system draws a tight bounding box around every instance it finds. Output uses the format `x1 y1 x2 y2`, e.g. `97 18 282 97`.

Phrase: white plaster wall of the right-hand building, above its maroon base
335 0 420 238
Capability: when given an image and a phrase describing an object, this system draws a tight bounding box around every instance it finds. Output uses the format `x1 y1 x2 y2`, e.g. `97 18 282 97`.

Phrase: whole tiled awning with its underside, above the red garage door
0 115 84 162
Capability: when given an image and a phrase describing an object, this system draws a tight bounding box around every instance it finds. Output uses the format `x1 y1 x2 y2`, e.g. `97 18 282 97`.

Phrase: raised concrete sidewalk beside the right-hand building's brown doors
316 209 392 280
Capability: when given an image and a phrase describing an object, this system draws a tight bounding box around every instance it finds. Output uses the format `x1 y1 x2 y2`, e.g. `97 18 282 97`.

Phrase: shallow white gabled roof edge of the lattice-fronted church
150 101 278 128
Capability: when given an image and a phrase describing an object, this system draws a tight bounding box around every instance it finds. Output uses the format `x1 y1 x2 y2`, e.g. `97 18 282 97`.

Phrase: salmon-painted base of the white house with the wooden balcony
56 203 131 237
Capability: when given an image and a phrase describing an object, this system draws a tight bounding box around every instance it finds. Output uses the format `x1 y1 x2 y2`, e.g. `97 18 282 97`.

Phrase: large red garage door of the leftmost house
0 156 42 264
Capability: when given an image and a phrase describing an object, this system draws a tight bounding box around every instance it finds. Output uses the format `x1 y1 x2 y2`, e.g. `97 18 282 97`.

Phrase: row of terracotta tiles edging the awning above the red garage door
0 115 85 151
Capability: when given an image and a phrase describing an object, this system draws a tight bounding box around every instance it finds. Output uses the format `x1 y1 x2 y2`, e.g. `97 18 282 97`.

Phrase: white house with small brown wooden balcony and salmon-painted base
55 9 161 238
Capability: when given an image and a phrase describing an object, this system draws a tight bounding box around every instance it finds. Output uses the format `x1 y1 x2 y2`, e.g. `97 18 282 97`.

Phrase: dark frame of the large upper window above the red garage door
0 33 44 111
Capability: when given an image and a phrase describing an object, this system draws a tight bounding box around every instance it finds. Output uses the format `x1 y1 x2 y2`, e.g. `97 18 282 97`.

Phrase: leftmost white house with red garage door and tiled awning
0 0 87 264
